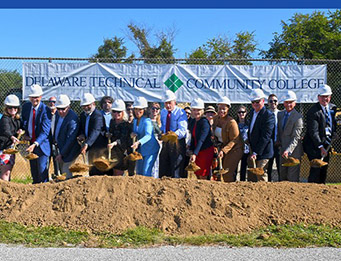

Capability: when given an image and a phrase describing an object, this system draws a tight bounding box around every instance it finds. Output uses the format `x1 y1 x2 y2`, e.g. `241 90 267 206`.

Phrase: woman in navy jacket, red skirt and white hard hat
188 98 214 179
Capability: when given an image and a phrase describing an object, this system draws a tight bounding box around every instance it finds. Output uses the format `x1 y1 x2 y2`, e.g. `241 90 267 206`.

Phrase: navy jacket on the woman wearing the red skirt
188 118 213 155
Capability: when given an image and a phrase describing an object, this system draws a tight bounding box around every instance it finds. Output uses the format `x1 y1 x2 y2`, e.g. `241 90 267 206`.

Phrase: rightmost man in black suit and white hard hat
303 84 336 184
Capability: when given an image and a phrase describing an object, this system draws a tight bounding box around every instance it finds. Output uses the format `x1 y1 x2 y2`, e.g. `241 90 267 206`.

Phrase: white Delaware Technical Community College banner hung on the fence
23 63 327 103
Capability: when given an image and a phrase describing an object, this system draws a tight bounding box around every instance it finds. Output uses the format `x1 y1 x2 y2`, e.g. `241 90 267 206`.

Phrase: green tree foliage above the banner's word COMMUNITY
189 32 257 64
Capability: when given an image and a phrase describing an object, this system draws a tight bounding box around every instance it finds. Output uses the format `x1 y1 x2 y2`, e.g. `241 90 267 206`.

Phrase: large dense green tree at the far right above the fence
261 10 341 59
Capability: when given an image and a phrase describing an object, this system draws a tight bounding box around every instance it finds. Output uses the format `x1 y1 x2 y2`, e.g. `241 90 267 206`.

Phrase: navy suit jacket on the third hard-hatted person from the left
54 109 80 162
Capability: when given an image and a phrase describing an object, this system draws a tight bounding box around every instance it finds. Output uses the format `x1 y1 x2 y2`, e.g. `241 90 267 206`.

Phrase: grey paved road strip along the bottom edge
0 245 341 261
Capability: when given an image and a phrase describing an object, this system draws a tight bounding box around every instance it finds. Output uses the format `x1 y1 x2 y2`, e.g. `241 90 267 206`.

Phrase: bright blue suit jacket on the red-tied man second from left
22 102 51 156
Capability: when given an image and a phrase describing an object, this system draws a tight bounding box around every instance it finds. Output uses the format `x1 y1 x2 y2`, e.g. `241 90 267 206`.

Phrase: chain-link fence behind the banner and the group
0 57 341 183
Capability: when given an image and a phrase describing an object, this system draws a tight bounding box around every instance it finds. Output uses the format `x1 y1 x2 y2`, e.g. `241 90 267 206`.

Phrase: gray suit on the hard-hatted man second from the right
277 109 303 182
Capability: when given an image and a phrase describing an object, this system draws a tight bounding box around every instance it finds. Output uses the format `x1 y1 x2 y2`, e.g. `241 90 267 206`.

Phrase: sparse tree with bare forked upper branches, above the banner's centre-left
128 23 175 63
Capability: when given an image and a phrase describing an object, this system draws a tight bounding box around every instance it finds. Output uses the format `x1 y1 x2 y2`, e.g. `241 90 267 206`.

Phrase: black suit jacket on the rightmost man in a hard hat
303 103 336 158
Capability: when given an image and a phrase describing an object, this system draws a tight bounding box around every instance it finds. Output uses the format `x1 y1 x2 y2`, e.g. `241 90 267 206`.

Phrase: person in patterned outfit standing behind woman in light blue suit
149 102 162 178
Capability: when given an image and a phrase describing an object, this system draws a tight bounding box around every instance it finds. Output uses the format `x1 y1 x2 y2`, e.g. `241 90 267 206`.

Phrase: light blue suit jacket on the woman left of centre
133 117 160 156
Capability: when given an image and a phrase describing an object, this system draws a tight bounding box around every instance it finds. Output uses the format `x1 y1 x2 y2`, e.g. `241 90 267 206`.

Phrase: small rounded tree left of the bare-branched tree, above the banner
92 36 134 62
